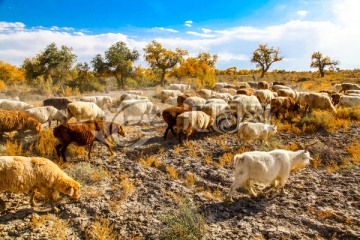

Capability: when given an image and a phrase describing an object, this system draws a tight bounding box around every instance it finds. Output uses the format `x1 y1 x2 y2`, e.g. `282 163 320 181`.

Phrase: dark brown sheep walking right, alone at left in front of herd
53 120 125 162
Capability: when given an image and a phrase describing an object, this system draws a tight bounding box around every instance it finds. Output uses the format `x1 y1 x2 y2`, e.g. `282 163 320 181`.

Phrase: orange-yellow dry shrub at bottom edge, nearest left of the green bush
85 216 120 240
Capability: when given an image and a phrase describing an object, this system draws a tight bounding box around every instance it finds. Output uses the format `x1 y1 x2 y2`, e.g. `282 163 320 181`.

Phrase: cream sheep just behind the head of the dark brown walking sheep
119 99 161 125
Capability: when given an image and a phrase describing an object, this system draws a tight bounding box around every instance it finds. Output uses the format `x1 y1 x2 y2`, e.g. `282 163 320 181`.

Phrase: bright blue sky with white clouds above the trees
0 0 360 71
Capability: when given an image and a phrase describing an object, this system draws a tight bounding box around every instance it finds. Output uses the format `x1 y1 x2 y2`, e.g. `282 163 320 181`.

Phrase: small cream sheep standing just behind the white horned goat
237 122 277 144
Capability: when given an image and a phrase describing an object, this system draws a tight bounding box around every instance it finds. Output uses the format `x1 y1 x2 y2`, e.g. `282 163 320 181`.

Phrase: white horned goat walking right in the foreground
226 144 312 201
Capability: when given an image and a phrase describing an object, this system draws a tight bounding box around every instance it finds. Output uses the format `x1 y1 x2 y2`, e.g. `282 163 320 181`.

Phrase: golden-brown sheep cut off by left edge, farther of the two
0 110 41 134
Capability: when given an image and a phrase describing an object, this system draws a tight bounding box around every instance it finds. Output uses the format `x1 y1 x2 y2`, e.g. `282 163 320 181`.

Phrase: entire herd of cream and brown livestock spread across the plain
0 81 360 211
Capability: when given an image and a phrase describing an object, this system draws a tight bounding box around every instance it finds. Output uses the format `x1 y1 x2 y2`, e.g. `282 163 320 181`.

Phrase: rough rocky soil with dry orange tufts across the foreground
0 90 360 239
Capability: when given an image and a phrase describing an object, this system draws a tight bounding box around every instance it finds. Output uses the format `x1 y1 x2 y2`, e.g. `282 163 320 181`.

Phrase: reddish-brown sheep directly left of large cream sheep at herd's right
270 97 300 118
